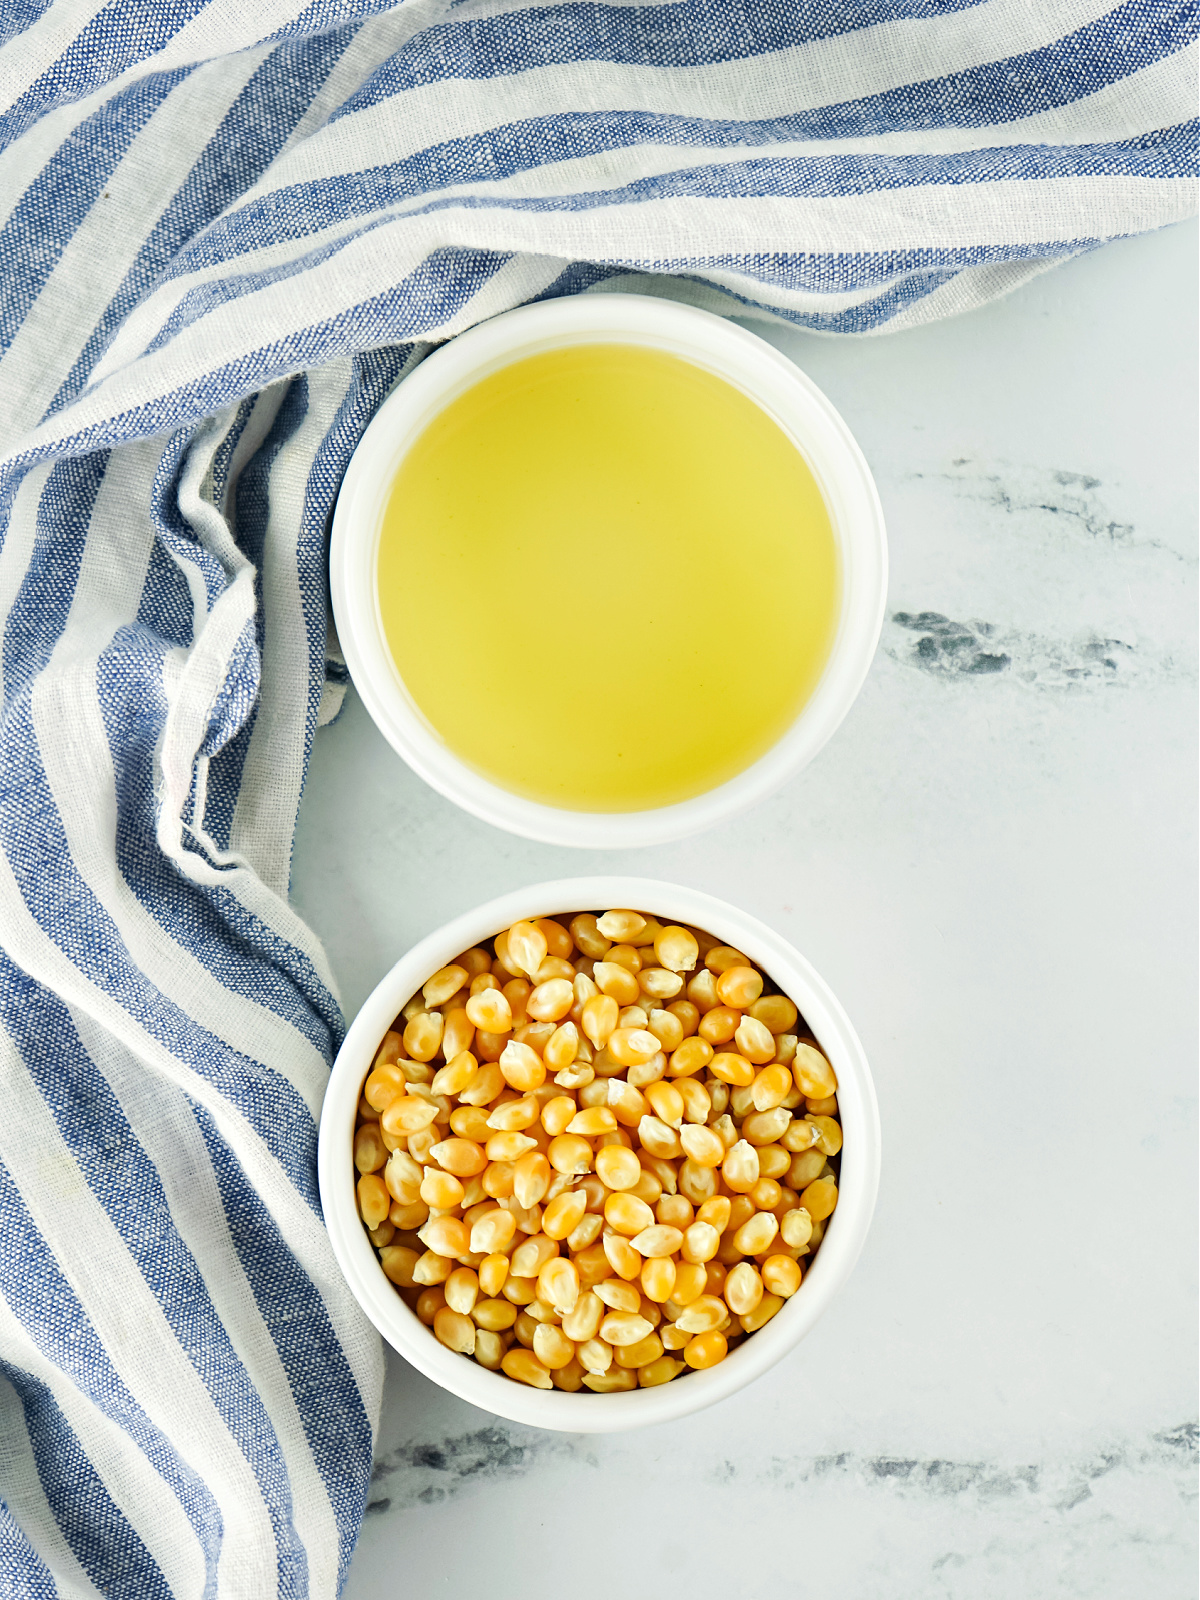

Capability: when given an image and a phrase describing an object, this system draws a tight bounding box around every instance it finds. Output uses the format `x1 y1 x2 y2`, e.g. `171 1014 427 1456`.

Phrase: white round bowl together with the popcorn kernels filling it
318 877 880 1432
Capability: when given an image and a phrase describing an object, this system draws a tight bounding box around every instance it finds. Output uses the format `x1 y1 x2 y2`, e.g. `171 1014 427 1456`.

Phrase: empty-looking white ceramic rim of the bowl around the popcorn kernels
318 877 880 1434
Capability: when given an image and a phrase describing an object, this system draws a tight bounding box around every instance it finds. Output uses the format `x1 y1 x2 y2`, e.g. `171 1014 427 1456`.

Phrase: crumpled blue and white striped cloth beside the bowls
0 0 1197 1600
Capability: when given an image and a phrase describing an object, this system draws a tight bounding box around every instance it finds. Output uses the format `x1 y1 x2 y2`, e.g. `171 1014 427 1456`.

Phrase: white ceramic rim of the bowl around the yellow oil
330 294 888 848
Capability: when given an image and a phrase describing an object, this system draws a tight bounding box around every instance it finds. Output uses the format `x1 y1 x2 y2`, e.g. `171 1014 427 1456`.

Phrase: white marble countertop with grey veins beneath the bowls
294 226 1197 1600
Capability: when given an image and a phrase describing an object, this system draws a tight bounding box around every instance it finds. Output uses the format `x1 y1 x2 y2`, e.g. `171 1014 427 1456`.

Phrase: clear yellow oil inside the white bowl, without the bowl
379 344 838 811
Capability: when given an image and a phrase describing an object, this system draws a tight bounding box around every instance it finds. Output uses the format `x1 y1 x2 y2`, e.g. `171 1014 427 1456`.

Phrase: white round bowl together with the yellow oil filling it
330 294 886 848
